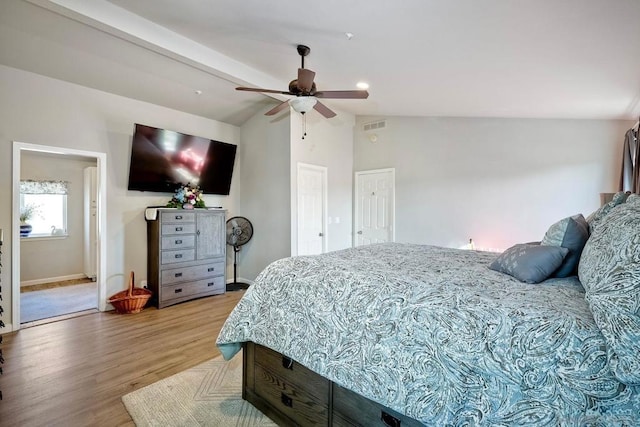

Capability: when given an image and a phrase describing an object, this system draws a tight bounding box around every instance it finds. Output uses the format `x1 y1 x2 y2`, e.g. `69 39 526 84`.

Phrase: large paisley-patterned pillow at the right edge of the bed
578 196 640 386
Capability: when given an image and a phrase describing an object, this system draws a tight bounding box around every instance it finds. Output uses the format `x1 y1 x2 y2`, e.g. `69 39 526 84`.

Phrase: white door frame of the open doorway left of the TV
11 141 107 331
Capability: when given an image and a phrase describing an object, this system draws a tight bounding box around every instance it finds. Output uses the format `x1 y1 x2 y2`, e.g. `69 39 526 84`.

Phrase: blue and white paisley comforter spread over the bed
217 243 640 426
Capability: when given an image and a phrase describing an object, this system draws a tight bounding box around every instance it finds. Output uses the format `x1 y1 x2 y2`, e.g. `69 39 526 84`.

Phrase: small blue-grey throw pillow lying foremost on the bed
489 243 569 283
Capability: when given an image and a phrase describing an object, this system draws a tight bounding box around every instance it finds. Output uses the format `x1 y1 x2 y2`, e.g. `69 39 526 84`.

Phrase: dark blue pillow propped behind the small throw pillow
540 214 589 277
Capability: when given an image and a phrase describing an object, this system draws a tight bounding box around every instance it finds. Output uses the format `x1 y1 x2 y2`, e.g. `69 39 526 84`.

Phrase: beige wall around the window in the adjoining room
20 151 96 284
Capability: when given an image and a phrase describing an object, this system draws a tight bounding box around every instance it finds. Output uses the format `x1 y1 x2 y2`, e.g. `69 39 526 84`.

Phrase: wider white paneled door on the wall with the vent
354 169 395 246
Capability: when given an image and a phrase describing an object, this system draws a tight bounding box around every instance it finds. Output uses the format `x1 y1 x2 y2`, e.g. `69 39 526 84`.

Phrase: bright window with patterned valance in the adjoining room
20 181 68 237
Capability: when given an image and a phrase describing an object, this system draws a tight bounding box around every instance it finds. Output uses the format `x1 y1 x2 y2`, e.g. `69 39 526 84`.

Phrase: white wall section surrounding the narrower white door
291 111 355 253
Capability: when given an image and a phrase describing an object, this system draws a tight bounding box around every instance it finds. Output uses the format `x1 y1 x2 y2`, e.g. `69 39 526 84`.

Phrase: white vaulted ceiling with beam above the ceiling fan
0 0 640 125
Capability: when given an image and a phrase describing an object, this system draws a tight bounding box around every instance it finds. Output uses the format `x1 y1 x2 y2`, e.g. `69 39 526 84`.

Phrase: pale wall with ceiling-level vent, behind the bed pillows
354 117 633 249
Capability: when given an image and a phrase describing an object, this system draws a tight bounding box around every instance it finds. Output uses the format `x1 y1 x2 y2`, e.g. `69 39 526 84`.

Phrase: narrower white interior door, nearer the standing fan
297 163 327 255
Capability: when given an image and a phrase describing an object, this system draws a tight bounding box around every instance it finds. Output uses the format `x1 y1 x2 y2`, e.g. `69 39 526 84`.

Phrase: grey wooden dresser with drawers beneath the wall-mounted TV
147 208 226 308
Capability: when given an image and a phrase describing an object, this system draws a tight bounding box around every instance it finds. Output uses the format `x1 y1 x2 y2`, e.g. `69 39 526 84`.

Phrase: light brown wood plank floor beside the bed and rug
0 291 244 427
